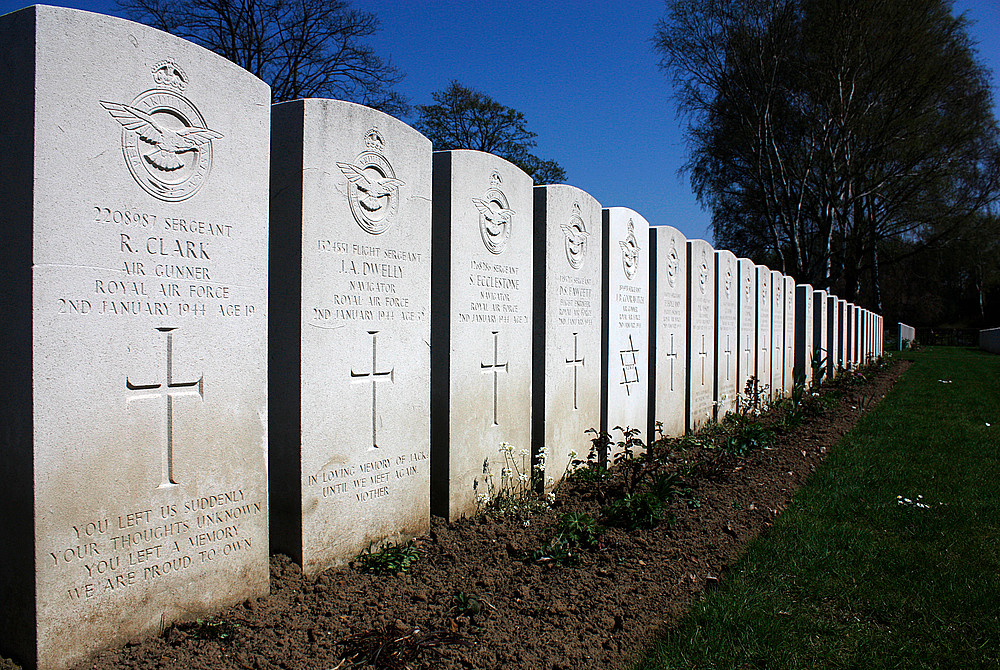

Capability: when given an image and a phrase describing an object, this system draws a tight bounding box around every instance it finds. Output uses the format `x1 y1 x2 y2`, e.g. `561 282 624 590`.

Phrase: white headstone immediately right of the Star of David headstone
646 226 687 439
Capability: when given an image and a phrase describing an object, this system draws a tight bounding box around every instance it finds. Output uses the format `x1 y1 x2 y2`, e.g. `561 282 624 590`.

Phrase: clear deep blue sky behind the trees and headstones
0 0 1000 247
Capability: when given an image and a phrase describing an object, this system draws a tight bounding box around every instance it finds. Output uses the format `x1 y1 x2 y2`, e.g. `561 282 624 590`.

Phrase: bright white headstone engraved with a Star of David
601 207 650 455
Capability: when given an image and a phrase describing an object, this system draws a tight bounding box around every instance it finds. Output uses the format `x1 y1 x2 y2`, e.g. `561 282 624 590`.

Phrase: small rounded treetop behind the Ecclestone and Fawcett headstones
414 81 566 185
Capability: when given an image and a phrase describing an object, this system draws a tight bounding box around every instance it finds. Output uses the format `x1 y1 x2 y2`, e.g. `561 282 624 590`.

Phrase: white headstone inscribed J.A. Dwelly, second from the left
269 99 431 575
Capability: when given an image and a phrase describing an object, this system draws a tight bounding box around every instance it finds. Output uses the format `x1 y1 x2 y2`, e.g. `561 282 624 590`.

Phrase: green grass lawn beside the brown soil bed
637 348 1000 670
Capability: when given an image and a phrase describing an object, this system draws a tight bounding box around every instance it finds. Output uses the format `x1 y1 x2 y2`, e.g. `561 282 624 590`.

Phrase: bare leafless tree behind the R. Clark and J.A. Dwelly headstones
118 0 408 116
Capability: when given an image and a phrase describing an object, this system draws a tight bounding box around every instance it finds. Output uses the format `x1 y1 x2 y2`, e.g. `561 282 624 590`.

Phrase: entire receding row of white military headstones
0 7 881 668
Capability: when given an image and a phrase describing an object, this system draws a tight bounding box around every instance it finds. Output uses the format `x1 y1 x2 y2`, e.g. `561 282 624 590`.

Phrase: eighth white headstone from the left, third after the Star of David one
714 250 740 421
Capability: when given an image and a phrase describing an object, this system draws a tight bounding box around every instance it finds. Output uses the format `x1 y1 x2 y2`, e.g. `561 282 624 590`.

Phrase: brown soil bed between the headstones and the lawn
79 363 907 670
